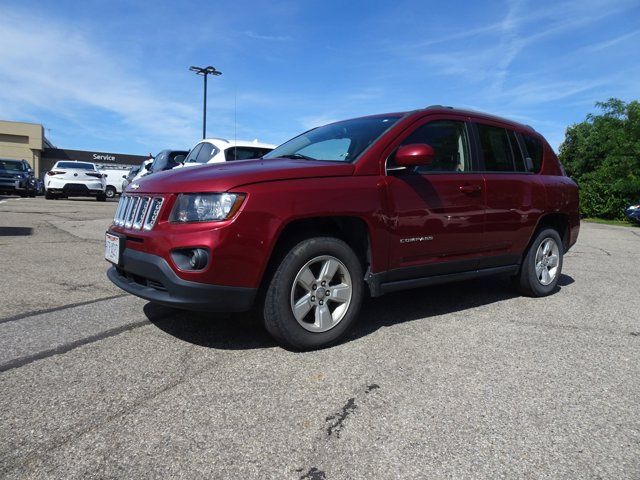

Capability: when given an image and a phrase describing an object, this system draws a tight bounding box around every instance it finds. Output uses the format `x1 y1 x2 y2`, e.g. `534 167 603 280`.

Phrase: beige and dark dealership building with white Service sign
0 120 148 176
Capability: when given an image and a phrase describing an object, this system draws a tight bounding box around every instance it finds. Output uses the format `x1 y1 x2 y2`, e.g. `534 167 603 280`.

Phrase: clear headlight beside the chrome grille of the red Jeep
169 193 245 223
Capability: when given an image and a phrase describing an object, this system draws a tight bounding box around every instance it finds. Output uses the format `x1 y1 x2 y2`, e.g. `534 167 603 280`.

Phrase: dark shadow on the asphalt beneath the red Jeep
144 274 574 350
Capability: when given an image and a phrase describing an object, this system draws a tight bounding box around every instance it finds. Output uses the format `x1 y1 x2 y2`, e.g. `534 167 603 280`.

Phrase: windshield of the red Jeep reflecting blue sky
263 115 400 162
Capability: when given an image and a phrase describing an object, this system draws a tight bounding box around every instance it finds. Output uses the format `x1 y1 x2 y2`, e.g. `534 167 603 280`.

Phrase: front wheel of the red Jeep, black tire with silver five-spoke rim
263 237 364 350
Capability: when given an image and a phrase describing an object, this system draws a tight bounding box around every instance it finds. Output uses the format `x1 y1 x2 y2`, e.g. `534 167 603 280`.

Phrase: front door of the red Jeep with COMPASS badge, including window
387 116 484 280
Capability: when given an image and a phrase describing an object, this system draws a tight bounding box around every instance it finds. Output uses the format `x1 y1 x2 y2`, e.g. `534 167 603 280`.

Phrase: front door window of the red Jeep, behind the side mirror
402 120 472 172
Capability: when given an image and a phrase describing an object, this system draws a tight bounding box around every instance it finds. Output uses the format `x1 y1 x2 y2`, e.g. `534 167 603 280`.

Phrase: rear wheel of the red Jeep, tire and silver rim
514 228 564 297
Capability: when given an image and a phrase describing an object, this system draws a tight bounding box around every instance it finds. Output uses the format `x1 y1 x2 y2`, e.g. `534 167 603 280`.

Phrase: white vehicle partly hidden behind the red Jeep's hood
176 138 276 168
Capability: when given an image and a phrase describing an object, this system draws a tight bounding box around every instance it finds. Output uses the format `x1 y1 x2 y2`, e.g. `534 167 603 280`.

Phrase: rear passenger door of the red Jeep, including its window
474 121 544 267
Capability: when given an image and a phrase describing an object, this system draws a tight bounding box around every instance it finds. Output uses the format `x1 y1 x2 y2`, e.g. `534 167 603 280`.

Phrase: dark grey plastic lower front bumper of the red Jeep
107 248 257 312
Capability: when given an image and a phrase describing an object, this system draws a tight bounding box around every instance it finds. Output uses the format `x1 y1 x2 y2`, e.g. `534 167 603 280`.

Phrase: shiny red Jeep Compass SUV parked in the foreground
106 106 580 349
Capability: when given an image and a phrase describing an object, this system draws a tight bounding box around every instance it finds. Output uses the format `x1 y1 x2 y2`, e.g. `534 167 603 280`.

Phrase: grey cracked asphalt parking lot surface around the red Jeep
0 197 640 480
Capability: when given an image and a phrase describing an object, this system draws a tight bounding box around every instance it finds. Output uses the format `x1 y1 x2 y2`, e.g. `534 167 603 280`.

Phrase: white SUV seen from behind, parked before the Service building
44 160 107 202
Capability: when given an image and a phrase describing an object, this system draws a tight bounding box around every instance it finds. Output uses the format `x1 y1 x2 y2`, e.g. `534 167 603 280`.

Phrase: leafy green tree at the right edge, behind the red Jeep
559 98 640 219
